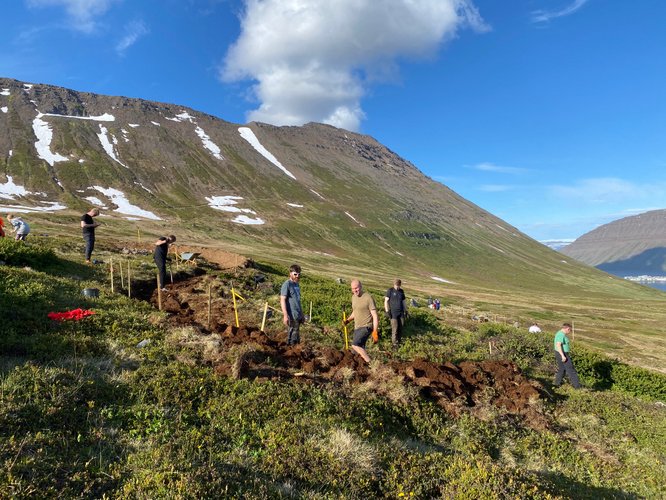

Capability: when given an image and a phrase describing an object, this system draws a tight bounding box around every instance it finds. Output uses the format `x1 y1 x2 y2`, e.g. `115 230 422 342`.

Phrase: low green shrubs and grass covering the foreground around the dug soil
0 237 666 498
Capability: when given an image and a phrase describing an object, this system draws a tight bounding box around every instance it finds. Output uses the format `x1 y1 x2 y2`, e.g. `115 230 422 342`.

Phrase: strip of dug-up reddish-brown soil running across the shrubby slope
151 276 548 428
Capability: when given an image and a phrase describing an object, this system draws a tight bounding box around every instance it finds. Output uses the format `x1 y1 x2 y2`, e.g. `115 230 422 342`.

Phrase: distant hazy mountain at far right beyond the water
561 210 666 276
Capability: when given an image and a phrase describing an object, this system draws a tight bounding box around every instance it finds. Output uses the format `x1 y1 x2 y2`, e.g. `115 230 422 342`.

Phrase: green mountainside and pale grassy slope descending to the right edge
0 78 666 371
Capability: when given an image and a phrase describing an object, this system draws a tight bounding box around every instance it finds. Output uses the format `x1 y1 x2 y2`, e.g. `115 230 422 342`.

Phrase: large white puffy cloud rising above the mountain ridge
220 0 489 130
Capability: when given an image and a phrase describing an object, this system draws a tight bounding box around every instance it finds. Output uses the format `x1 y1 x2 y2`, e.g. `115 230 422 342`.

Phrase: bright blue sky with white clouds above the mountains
0 0 666 240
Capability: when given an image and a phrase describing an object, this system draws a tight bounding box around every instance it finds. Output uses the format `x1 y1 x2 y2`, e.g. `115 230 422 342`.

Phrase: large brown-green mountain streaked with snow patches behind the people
0 78 644 290
